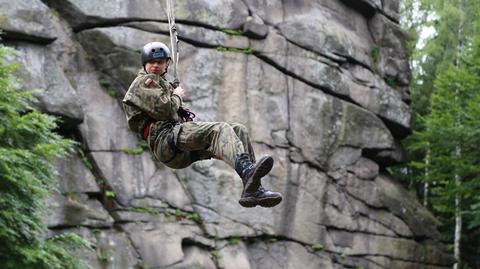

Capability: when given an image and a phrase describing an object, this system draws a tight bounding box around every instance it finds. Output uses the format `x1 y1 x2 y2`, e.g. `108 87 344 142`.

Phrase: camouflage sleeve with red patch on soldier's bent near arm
123 75 182 120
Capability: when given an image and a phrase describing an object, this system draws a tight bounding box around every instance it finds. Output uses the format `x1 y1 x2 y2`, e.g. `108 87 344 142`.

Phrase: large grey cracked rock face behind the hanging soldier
0 0 452 269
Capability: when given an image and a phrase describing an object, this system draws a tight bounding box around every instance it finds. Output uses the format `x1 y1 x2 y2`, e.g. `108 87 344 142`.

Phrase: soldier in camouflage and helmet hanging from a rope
123 42 282 207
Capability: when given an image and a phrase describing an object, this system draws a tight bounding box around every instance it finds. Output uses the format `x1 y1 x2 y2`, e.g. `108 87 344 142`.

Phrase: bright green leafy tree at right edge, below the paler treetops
415 44 480 268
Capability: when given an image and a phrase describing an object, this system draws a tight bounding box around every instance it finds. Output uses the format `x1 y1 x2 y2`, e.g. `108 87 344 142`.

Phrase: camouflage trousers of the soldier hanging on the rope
154 121 255 168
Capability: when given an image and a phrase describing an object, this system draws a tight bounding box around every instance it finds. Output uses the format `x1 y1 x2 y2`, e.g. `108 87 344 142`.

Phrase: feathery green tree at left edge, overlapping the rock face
0 46 89 269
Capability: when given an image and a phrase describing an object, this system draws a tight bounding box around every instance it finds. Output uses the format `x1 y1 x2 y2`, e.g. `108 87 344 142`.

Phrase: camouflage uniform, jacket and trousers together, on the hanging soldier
123 70 255 168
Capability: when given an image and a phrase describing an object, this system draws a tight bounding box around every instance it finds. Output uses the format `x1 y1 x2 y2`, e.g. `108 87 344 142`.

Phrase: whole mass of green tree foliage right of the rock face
396 0 480 268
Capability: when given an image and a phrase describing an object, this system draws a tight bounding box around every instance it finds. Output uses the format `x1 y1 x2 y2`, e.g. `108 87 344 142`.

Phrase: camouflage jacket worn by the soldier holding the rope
123 70 183 135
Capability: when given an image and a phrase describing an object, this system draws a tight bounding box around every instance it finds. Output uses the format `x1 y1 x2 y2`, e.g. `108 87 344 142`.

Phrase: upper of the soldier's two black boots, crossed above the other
235 153 273 193
